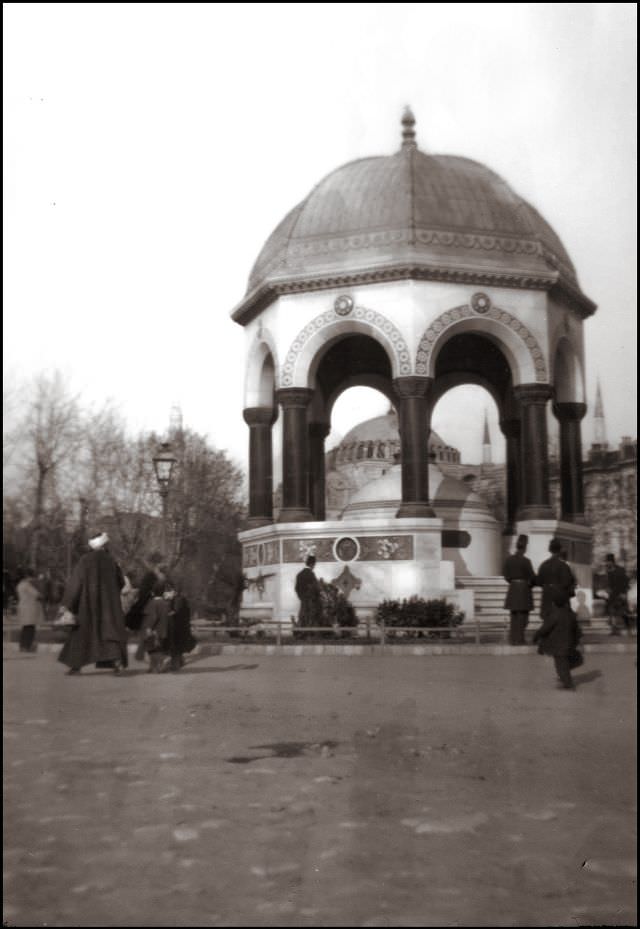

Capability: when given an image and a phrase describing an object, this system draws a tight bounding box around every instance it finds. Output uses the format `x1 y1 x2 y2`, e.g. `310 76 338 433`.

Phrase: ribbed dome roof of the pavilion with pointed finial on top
238 114 595 321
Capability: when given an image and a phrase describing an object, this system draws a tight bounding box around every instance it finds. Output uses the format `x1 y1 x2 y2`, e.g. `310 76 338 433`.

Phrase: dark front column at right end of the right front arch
514 384 554 519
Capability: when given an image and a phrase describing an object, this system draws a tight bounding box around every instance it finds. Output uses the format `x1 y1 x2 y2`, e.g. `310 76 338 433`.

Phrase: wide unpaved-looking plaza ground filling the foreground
3 646 636 927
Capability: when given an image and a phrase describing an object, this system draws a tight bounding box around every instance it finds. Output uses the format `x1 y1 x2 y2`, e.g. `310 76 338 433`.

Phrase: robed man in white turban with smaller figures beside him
54 532 196 674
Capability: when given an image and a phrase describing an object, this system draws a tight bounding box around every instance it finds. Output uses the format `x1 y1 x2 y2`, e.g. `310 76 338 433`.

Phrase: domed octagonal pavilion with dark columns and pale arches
232 110 596 620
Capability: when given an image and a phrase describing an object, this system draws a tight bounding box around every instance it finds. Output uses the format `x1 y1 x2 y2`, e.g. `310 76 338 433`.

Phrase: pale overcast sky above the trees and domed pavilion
3 3 636 465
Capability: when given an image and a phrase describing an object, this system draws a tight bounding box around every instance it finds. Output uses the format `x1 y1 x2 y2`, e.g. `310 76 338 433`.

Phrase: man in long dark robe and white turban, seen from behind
58 532 127 674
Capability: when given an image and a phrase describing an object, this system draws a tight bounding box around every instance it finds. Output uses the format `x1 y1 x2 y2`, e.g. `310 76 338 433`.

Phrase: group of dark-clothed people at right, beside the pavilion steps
504 535 629 690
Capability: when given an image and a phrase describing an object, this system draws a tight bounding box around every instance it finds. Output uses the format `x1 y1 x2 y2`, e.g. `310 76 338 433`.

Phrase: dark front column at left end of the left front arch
276 387 313 523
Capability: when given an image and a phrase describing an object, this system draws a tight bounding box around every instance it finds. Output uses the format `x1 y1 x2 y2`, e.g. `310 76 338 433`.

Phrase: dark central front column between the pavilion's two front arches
393 377 436 517
